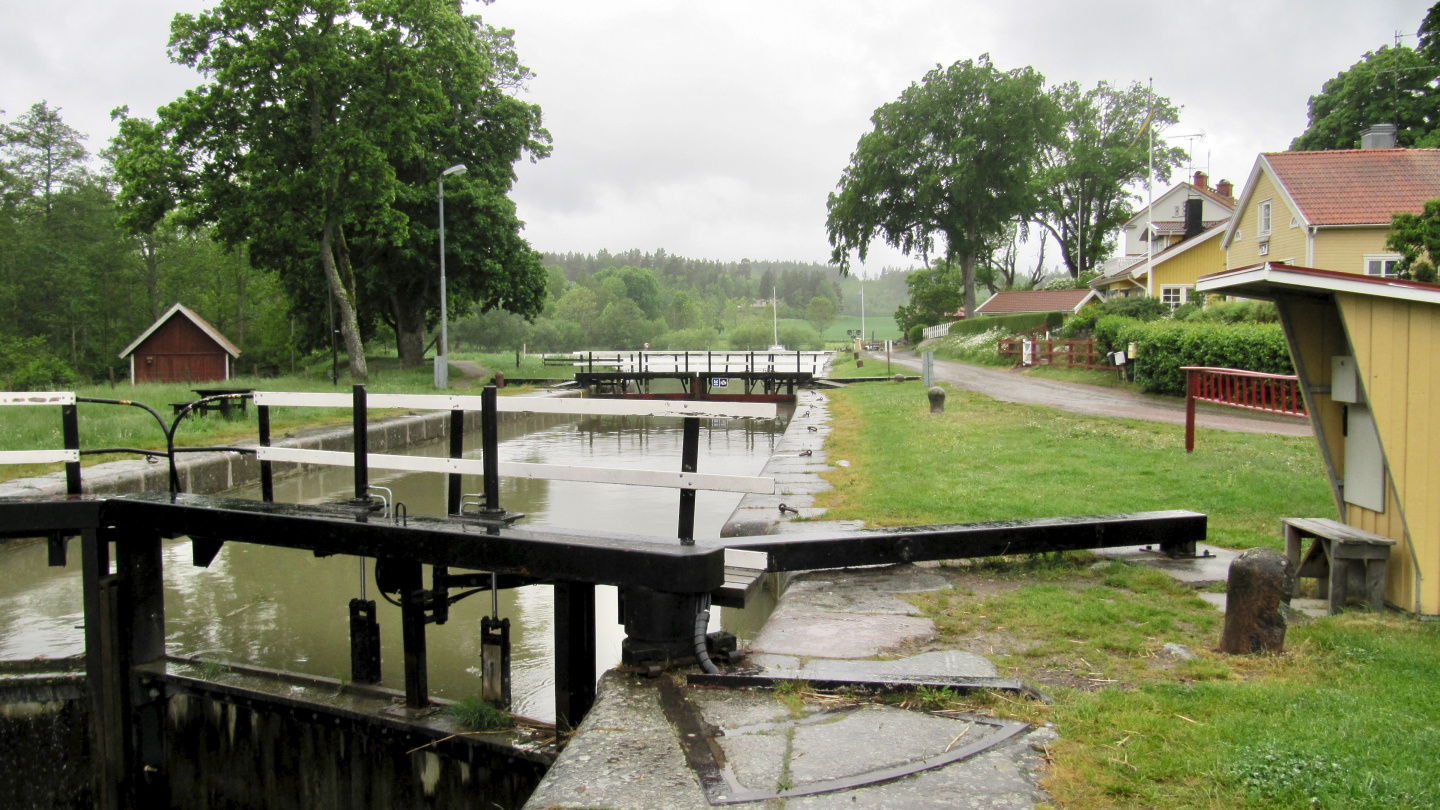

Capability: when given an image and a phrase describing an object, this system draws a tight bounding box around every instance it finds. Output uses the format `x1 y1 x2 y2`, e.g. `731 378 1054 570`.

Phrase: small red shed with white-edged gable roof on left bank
120 304 240 383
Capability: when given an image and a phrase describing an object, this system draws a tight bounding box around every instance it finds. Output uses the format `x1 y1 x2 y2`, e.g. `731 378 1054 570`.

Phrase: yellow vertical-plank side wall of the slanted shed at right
1335 293 1440 614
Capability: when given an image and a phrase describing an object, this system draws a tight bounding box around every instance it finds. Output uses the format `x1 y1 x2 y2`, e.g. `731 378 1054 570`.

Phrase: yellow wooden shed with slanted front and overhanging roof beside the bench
1198 263 1440 615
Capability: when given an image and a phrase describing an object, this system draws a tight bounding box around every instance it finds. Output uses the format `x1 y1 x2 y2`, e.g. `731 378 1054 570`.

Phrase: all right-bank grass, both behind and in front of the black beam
821 382 1440 809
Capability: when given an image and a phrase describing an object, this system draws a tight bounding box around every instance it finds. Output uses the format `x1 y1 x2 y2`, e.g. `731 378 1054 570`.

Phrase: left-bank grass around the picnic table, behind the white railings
0 356 486 480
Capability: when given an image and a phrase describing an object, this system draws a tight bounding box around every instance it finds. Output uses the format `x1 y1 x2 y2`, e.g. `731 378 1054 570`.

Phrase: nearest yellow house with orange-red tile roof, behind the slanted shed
1221 140 1440 277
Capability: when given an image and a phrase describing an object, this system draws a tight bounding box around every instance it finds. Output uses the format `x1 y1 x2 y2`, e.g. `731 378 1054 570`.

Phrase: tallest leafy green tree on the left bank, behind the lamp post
122 0 549 379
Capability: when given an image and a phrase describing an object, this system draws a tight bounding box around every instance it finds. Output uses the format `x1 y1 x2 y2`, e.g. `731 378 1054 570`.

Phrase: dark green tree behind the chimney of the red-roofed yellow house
1290 44 1440 151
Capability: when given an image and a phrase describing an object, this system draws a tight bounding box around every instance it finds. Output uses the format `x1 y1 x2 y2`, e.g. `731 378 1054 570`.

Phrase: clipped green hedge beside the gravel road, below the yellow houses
1094 316 1295 395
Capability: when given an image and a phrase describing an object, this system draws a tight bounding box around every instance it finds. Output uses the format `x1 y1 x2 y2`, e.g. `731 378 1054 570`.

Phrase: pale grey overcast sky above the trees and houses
0 0 1427 272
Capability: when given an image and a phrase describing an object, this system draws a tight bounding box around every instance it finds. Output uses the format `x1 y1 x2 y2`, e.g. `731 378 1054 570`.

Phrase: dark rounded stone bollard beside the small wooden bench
1220 549 1295 656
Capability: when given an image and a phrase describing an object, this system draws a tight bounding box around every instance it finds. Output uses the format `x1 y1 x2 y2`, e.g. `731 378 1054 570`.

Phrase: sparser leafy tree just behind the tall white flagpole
1040 82 1185 278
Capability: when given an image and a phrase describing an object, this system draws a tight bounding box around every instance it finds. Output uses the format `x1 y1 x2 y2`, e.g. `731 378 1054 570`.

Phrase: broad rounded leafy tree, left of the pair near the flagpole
827 55 1061 313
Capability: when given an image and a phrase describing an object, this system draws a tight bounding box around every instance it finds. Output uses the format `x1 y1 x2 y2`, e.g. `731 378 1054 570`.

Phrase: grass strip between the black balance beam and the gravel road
816 380 1335 548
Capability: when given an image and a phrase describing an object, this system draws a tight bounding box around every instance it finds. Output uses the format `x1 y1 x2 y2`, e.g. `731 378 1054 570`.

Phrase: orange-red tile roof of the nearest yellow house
1264 148 1440 225
